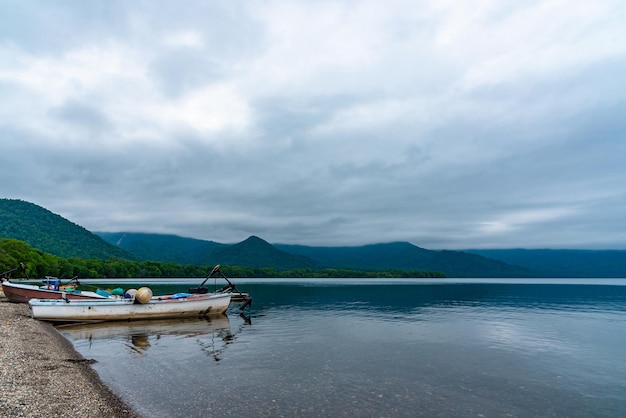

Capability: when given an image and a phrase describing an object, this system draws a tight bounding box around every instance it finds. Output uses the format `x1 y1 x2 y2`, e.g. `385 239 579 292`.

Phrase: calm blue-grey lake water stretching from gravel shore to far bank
59 279 626 417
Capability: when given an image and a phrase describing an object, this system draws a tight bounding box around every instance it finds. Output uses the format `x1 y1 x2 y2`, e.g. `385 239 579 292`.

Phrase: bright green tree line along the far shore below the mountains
0 238 445 279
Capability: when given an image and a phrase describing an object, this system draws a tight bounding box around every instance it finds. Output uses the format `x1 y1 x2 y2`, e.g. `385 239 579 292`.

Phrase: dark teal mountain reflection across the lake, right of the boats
227 280 626 315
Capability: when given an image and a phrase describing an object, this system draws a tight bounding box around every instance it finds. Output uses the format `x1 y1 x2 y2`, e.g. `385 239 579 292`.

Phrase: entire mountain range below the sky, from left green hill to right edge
0 199 626 278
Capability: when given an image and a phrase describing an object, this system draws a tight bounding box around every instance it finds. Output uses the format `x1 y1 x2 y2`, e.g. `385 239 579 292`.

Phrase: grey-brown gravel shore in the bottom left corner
0 298 137 417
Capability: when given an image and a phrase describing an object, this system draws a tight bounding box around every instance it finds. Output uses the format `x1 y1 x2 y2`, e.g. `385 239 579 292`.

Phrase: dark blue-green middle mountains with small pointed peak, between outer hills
96 232 536 277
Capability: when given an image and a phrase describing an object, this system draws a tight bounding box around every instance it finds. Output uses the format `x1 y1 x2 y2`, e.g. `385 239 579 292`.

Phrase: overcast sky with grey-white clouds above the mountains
0 0 626 249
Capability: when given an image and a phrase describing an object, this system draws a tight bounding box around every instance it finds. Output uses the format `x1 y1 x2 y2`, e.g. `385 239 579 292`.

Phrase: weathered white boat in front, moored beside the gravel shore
28 293 232 322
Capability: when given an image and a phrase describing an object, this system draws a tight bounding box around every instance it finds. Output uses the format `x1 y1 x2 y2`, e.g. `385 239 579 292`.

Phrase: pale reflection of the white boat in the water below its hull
57 314 230 340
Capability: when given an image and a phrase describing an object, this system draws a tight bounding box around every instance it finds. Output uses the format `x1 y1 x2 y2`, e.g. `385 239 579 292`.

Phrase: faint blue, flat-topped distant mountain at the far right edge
465 249 626 278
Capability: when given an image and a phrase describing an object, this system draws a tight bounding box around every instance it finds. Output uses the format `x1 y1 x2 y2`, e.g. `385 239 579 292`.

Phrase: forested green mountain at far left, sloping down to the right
0 199 138 260
